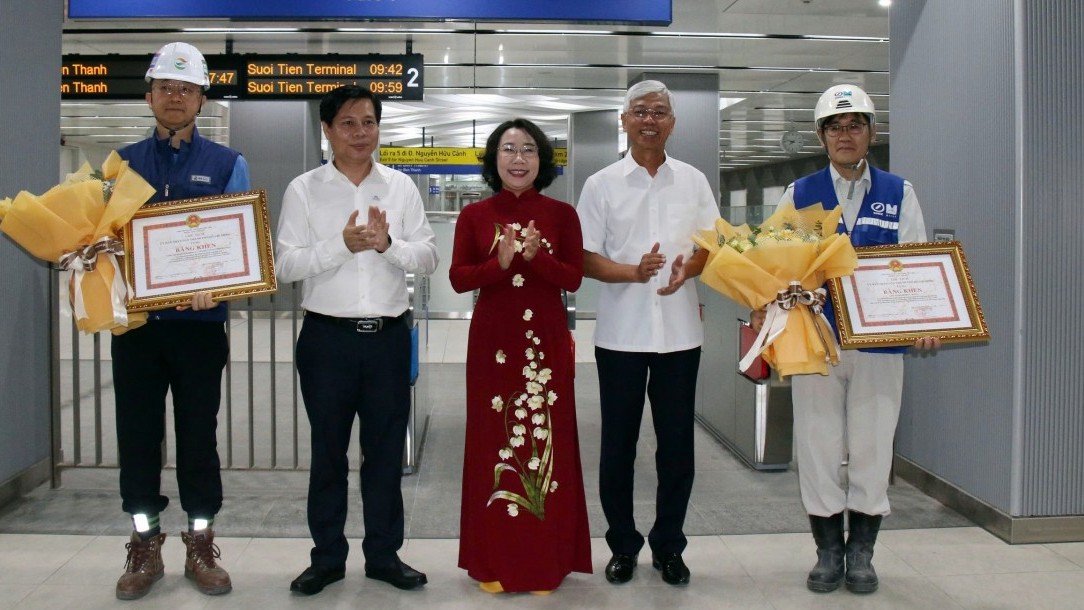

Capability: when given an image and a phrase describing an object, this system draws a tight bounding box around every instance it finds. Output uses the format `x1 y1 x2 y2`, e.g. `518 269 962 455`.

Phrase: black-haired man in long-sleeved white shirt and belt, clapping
276 86 437 595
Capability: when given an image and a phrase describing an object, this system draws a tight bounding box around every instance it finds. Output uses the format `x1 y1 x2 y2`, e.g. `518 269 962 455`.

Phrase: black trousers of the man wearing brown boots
109 320 230 518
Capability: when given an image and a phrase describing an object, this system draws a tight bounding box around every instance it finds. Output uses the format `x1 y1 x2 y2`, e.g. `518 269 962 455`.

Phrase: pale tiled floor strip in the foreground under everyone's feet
0 528 1084 610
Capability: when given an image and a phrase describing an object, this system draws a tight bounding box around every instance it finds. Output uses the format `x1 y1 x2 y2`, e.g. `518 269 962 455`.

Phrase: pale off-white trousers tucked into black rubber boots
790 350 903 517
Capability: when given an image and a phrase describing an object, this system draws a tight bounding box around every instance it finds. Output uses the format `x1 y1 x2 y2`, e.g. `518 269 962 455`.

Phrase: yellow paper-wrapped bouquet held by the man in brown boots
0 152 154 334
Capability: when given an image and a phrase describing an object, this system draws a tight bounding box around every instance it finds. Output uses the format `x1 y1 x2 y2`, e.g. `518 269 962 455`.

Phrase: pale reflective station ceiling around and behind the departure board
62 0 890 170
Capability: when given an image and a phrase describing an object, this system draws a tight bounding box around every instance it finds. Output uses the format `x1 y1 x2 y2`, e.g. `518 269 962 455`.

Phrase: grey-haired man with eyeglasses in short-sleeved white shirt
577 80 719 585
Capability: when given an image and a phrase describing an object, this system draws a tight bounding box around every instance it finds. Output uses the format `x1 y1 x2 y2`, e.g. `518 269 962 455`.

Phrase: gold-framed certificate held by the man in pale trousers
828 242 990 349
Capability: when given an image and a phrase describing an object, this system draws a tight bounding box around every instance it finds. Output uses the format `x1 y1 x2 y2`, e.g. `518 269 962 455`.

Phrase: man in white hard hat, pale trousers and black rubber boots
752 85 941 593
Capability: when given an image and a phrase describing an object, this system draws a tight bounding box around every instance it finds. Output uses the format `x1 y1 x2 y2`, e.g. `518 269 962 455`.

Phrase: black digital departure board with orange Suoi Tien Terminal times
61 54 425 101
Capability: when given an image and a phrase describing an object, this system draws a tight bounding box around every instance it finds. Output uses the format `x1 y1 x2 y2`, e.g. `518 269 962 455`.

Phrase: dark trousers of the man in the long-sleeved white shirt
297 315 411 568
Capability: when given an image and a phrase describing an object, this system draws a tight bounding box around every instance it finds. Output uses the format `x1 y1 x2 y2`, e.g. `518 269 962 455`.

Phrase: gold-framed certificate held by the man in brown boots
125 191 278 311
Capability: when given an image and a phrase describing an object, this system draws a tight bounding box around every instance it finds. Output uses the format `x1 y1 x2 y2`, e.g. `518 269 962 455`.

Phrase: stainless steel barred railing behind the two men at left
53 273 428 485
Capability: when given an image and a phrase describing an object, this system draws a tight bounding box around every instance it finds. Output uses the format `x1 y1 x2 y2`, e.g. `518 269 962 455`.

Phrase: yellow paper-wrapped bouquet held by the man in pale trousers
693 204 857 377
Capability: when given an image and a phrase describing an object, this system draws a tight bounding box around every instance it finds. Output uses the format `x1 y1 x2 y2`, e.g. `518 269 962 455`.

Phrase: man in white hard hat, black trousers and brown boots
112 42 249 599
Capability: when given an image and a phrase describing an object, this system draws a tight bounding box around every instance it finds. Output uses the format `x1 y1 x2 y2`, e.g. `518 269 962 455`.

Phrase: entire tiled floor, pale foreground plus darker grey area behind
8 322 1084 610
